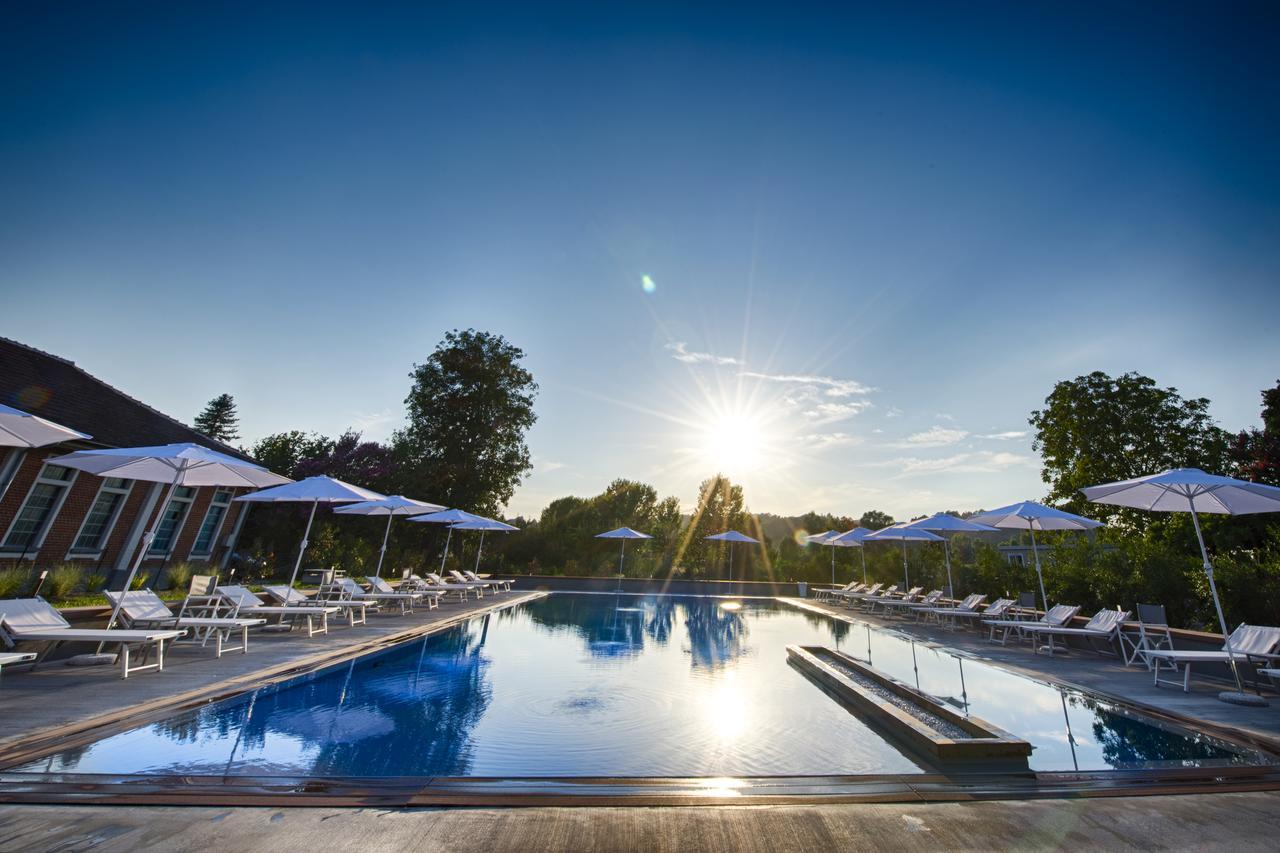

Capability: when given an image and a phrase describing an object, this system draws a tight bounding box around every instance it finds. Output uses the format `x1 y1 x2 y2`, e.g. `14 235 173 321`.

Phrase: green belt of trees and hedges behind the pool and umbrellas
204 329 1280 626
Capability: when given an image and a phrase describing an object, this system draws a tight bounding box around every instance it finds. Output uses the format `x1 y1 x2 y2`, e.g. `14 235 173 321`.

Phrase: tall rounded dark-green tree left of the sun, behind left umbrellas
393 329 538 515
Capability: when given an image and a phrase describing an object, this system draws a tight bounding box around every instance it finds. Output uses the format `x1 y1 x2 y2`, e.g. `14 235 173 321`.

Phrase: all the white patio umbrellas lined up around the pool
0 403 1280 703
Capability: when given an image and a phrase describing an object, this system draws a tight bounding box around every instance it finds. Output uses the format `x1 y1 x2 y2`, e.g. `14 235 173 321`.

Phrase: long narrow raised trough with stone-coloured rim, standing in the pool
787 646 1032 774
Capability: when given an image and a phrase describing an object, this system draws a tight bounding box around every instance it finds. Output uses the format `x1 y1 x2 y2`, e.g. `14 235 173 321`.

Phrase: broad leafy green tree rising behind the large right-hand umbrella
1030 371 1228 517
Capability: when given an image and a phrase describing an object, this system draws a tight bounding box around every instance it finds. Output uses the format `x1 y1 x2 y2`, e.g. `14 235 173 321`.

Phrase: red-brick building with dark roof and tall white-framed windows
0 338 261 584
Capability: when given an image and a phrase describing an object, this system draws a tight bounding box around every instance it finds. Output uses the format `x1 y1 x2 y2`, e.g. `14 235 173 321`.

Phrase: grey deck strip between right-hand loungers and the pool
783 598 1280 748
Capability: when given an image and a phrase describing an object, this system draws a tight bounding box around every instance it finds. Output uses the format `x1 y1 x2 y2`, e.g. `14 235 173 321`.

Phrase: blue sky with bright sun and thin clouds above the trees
0 4 1280 515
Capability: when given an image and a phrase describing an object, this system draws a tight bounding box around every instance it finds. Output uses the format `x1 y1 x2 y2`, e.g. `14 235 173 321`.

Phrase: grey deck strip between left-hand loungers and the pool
0 587 545 758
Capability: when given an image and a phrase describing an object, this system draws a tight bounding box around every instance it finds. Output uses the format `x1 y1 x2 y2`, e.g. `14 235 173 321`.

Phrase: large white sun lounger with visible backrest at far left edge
0 597 186 679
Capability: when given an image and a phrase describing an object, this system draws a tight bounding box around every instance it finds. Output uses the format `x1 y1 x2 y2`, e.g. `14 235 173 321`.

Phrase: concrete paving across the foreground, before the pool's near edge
0 793 1280 853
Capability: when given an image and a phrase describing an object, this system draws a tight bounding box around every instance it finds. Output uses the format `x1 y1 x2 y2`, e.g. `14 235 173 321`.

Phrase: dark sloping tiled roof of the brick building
0 337 248 459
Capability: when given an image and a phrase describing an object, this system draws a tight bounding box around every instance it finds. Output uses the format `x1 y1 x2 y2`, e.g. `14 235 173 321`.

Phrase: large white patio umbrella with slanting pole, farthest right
1080 467 1280 704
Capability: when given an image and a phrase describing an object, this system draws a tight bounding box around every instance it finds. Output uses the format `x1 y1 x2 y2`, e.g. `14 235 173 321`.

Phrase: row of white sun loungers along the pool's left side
0 573 511 678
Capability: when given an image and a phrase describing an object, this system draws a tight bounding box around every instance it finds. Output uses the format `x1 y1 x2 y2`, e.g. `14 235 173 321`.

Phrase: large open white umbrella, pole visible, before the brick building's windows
49 443 291 653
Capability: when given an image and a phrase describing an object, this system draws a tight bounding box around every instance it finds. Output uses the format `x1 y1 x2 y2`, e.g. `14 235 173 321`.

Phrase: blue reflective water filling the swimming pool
9 593 1267 777
